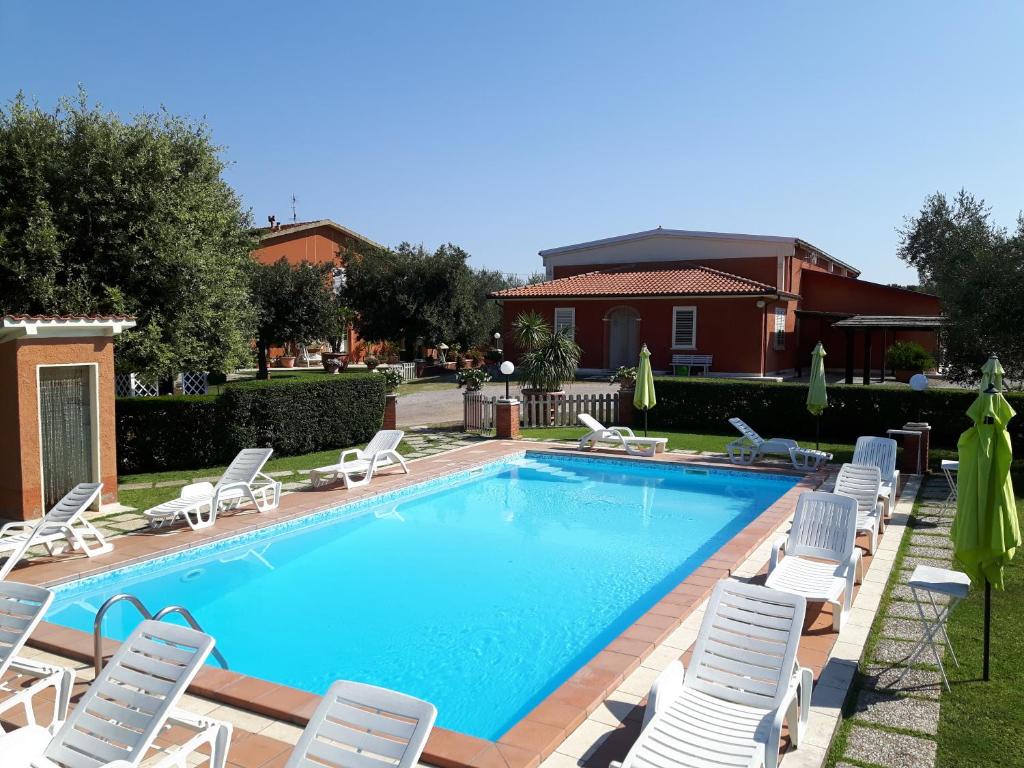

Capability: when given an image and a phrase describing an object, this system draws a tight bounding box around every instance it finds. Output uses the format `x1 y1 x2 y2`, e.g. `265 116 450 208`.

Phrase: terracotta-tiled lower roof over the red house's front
490 266 788 299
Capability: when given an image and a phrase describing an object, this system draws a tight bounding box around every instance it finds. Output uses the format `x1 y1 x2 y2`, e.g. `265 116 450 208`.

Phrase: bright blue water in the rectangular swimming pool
49 454 796 738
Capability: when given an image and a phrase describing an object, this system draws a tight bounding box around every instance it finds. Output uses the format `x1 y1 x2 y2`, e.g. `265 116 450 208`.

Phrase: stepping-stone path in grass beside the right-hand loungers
837 478 955 768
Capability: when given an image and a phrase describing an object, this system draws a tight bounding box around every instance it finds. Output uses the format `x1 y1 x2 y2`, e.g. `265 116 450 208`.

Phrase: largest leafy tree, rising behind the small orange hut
0 93 255 376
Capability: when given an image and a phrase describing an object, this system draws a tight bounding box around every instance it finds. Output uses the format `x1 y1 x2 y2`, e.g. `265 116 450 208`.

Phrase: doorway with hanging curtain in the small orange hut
39 366 93 509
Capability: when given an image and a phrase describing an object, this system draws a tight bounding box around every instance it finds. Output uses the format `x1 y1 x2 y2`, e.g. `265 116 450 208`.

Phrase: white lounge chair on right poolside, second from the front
765 492 861 631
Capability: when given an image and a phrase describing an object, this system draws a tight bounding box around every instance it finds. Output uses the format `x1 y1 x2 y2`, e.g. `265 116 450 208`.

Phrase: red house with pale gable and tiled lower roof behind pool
492 227 941 383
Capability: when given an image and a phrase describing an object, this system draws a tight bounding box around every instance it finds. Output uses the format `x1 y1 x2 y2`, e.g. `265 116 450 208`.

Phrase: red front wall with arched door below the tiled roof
503 298 764 374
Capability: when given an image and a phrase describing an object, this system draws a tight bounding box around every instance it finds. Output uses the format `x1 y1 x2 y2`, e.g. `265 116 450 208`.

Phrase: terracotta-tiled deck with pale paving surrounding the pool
4 440 871 768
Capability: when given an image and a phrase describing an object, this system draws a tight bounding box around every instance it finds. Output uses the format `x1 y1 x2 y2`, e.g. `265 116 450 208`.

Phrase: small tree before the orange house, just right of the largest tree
252 258 337 379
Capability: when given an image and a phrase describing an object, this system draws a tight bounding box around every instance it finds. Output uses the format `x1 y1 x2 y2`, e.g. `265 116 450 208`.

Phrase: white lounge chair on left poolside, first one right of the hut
142 449 281 530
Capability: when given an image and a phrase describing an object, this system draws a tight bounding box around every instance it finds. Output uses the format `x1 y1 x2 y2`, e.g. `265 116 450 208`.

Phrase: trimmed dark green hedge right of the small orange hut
117 374 384 474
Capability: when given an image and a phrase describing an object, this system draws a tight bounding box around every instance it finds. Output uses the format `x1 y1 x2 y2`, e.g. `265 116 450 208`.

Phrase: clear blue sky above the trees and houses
0 0 1024 282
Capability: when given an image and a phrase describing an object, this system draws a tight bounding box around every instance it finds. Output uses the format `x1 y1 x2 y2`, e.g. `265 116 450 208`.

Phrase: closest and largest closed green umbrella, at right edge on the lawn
949 385 1021 680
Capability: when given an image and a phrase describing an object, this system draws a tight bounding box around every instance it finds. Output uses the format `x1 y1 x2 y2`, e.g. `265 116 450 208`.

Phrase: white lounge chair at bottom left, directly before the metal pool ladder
0 621 231 768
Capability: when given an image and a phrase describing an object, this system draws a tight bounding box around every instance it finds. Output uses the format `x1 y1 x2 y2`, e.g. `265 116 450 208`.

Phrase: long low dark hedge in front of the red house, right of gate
648 378 1024 447
